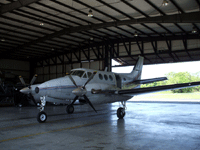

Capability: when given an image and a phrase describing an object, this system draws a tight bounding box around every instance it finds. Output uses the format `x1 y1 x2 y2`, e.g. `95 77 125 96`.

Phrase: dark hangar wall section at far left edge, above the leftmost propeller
0 59 30 83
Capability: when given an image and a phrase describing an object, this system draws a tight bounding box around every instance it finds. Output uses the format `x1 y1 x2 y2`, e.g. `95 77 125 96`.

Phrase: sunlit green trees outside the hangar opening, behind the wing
141 72 200 93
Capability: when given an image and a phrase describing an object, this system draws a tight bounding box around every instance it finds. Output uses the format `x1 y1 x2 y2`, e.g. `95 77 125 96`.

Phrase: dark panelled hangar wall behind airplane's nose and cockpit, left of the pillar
35 46 105 83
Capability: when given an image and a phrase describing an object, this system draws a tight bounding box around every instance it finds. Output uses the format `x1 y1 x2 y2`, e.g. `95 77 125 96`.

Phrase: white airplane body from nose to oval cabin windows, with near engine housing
38 68 132 104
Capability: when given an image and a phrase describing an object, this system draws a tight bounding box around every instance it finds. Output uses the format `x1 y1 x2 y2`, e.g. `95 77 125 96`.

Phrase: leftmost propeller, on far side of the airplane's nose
19 74 37 106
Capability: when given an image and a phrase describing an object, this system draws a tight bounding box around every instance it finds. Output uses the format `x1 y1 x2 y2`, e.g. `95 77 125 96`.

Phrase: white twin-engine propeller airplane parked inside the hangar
20 56 200 123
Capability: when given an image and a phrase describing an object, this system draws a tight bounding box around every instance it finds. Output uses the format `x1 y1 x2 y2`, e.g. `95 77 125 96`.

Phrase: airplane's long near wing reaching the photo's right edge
115 82 200 96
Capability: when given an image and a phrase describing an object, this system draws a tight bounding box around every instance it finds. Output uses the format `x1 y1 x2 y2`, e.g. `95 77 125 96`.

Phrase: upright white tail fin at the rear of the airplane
128 56 144 81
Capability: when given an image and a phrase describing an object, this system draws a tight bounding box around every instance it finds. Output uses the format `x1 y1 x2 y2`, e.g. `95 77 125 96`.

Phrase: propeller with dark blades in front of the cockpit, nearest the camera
69 71 97 112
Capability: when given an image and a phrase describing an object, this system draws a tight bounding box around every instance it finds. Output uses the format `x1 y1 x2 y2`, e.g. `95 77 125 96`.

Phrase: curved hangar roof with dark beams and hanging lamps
0 0 200 64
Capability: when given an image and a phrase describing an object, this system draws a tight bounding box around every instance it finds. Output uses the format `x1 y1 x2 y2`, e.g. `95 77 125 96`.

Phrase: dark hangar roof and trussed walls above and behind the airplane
0 0 200 83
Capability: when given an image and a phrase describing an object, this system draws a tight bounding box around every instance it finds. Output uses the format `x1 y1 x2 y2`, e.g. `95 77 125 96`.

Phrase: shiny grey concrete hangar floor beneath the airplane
0 102 200 150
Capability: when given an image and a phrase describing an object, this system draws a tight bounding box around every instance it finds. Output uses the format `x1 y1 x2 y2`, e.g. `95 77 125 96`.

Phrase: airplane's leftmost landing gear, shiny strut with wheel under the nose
37 96 47 123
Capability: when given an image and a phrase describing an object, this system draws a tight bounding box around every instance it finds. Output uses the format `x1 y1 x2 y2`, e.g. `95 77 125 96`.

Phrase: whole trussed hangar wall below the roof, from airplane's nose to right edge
35 39 200 83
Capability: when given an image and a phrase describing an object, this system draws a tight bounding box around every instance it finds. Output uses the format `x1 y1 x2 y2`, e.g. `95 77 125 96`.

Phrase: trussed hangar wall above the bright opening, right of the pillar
112 39 200 65
